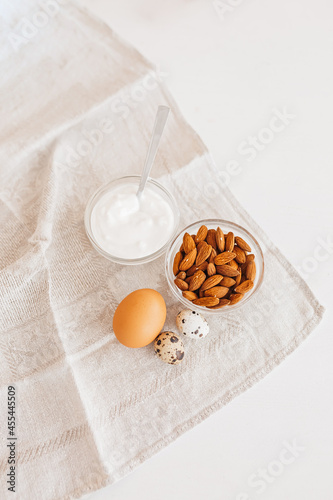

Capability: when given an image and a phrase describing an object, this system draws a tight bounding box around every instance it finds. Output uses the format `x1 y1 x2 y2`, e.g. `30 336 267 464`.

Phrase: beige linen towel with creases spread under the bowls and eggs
0 0 322 500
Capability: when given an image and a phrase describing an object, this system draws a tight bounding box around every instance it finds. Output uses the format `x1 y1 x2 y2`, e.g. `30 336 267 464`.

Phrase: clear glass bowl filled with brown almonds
165 219 264 314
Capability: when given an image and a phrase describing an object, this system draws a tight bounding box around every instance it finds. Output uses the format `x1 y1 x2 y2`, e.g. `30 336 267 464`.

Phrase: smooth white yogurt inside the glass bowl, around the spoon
91 184 175 259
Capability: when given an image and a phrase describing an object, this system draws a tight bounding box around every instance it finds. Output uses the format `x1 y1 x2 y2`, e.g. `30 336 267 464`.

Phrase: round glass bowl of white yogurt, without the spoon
84 176 179 264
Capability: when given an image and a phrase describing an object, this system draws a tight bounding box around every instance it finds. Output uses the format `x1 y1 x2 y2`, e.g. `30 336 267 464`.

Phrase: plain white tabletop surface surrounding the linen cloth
81 0 333 500
